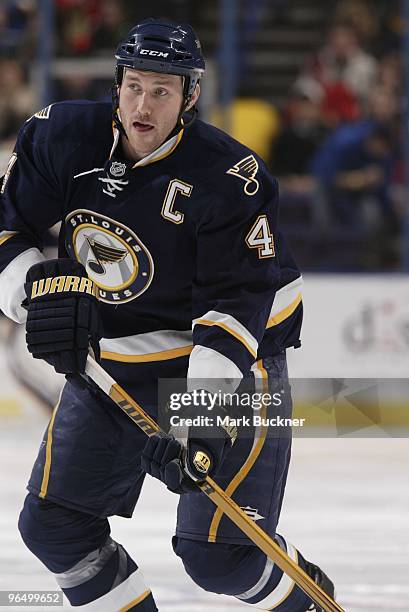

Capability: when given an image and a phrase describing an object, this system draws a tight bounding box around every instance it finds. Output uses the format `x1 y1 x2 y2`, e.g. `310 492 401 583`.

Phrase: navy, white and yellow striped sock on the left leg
19 486 157 612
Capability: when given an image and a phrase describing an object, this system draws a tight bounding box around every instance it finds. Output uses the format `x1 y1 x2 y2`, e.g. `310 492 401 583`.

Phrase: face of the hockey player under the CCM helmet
119 68 199 160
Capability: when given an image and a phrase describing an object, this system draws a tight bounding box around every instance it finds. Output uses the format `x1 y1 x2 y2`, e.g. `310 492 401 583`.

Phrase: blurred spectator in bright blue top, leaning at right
311 87 398 230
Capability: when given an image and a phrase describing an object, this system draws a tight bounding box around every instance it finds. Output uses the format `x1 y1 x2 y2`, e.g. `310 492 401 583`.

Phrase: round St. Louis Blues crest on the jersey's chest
65 209 154 304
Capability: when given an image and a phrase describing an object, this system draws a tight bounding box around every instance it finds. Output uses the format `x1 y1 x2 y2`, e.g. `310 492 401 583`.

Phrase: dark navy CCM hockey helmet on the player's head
115 19 205 103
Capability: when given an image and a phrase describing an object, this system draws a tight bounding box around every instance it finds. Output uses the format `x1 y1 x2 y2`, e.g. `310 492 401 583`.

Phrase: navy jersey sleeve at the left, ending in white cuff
0 116 63 323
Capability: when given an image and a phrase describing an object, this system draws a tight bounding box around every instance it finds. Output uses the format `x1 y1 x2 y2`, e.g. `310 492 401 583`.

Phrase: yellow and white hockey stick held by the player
85 355 344 612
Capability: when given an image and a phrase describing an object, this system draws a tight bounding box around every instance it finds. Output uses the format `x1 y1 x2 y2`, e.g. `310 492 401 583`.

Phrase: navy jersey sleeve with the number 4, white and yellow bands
188 162 280 390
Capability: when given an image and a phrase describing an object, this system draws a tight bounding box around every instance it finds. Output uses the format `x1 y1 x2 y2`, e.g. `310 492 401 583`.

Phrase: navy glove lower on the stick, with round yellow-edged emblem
141 396 237 494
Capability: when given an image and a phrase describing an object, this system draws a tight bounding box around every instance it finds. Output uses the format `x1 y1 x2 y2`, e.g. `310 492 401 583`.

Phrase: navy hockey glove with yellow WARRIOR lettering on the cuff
23 259 101 374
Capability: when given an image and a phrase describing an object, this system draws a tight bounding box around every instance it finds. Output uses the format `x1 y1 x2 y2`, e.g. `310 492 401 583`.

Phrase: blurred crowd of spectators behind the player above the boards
0 0 408 271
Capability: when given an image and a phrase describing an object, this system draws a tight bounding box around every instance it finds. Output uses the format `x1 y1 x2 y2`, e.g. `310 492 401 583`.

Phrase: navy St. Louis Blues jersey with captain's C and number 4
0 101 302 396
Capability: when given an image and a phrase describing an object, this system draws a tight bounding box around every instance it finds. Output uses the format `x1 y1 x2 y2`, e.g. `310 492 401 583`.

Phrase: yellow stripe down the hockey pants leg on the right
207 359 268 542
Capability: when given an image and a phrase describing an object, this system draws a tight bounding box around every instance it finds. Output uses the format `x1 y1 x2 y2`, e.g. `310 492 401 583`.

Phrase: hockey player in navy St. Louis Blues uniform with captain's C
0 20 333 612
